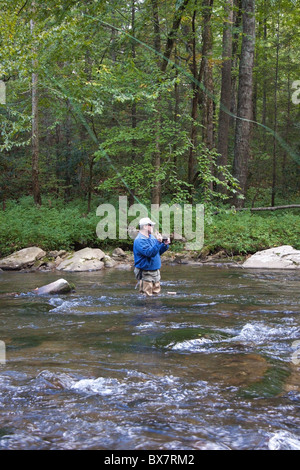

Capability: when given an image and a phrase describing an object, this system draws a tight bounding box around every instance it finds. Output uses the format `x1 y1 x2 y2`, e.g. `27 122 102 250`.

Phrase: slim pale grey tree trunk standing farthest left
30 2 42 206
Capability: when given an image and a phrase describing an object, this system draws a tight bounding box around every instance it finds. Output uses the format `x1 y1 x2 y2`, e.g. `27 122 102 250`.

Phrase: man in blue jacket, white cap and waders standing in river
133 217 170 296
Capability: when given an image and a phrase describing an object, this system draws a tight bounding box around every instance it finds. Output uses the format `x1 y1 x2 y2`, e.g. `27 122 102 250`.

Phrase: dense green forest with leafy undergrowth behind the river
0 0 300 254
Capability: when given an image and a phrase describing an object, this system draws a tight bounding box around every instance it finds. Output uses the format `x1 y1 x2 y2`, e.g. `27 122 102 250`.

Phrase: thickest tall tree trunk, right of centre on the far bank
233 0 255 207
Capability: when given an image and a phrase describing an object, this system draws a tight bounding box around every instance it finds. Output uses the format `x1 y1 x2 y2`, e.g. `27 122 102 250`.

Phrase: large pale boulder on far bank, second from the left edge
56 248 105 272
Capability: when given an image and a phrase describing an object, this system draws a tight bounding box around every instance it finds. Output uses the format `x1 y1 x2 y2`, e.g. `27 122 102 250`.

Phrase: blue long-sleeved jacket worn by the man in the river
133 233 169 271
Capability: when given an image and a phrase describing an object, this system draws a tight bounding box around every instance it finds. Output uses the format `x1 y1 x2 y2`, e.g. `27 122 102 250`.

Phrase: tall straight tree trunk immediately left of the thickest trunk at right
218 0 233 193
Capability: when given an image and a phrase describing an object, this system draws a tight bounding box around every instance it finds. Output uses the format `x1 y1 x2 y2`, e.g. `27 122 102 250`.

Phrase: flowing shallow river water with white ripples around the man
0 266 300 451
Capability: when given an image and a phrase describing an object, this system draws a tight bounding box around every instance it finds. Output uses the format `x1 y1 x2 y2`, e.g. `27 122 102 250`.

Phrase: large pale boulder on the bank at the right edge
243 245 300 269
